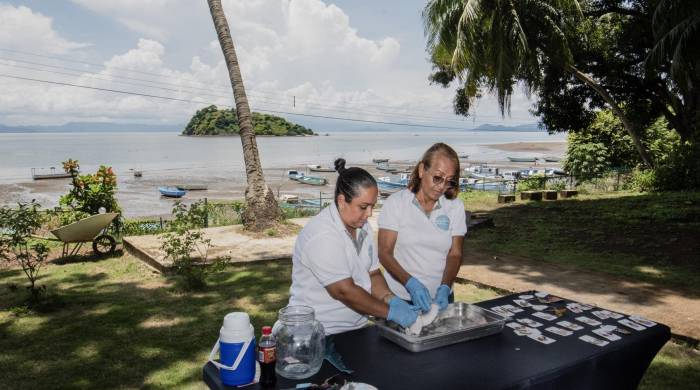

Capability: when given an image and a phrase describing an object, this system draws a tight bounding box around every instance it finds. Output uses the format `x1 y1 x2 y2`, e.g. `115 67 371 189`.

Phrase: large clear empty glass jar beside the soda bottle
275 305 326 379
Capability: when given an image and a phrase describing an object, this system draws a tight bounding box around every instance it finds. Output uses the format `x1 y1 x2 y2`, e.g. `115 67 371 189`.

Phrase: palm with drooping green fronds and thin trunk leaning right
423 0 652 166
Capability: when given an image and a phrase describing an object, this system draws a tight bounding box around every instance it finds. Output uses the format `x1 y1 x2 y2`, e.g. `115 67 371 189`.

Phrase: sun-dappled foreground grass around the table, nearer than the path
0 251 700 389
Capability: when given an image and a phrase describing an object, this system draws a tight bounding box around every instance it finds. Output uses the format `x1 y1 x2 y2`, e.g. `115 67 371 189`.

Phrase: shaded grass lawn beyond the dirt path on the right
466 192 700 294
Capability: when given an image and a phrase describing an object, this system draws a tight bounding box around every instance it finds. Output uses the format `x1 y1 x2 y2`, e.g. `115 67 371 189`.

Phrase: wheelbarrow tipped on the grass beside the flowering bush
51 213 119 257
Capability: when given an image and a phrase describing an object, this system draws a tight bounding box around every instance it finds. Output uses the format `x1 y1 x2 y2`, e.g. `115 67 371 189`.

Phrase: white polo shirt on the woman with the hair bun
289 203 379 335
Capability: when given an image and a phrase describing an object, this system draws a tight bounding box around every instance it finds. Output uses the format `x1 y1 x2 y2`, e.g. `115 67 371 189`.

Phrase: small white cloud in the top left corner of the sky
0 3 88 54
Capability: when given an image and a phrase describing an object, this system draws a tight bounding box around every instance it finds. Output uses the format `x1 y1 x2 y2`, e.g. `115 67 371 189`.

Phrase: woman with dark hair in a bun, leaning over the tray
289 158 419 335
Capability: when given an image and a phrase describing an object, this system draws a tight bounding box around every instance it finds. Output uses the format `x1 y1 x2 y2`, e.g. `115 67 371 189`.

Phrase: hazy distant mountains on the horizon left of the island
0 122 180 133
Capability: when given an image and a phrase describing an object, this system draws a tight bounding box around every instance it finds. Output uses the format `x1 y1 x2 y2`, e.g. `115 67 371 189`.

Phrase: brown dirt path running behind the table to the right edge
458 244 700 341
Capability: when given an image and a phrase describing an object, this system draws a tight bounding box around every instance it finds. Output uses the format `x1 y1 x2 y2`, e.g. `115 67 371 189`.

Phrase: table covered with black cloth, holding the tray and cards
203 293 671 390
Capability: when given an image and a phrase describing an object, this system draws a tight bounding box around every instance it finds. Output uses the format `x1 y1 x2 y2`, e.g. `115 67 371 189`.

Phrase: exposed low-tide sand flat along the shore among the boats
0 142 566 218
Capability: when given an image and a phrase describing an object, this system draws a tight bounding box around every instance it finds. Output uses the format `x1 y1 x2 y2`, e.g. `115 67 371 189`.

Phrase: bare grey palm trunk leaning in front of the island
207 0 280 231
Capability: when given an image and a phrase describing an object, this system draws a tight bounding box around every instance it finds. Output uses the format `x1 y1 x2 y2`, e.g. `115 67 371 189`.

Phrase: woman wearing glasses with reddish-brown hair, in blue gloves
379 143 467 312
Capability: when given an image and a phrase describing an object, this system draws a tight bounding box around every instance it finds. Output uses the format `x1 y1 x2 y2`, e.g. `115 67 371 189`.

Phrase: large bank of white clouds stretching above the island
0 0 530 124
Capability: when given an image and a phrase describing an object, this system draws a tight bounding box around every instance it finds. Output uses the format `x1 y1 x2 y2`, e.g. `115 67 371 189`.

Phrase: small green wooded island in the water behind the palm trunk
182 105 315 136
